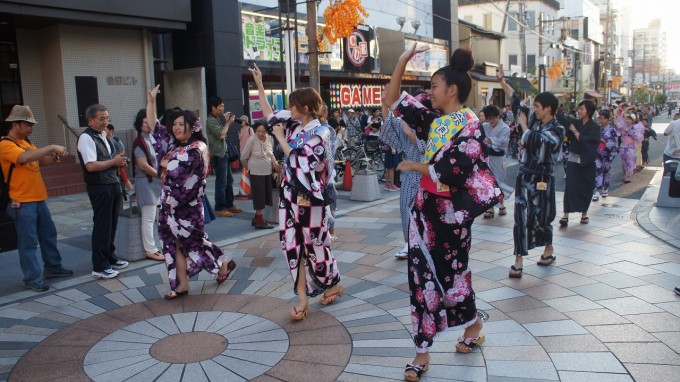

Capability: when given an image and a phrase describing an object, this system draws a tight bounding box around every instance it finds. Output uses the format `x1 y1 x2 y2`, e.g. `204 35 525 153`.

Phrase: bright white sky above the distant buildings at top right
620 0 680 74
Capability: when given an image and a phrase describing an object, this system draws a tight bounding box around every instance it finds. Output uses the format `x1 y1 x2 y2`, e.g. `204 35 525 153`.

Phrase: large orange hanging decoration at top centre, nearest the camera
319 0 368 44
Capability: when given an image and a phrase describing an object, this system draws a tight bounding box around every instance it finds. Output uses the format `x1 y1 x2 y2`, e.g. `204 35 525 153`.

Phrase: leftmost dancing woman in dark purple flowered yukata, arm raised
146 85 236 300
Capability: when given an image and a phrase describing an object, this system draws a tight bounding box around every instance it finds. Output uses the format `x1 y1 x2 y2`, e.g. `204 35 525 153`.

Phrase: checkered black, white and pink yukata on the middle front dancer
268 110 340 297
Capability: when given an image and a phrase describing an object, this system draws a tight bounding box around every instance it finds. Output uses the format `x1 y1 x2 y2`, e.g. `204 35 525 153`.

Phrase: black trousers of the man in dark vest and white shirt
87 184 121 272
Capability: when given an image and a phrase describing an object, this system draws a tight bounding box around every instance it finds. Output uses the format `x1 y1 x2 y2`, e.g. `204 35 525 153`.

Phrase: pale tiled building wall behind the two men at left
17 24 151 152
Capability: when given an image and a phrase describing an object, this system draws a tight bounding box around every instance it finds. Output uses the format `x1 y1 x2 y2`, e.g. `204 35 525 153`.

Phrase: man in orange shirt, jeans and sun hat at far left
0 105 73 292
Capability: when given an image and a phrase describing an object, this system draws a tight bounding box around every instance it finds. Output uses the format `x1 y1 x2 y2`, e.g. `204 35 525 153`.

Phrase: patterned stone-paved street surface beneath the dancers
0 187 680 381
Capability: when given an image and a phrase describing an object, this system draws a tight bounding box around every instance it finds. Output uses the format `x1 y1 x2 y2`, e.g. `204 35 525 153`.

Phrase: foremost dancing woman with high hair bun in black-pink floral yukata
385 45 502 381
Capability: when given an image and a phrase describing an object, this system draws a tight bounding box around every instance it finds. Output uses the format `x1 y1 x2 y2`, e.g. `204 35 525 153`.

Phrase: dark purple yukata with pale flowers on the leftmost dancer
154 122 229 290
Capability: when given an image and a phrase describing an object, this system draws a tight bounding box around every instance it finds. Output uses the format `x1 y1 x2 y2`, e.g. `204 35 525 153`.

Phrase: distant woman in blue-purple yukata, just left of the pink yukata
593 110 619 201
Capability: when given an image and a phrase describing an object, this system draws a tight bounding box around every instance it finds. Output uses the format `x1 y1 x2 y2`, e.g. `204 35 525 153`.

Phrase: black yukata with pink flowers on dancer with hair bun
395 93 502 353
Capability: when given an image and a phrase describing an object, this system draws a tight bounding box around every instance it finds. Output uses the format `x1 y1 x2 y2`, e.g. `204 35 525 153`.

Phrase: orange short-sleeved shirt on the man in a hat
0 139 47 203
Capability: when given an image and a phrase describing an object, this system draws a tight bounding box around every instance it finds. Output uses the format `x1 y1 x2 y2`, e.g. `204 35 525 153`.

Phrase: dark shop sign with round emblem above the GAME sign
342 25 378 73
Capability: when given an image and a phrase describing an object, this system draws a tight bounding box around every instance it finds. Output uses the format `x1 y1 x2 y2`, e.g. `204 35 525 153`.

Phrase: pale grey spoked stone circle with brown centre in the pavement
83 312 289 381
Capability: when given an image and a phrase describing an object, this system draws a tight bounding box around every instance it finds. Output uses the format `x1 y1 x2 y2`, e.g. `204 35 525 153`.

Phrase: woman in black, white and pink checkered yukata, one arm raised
250 65 344 320
